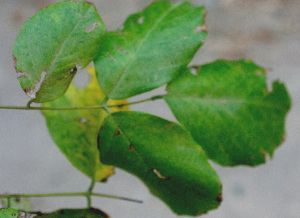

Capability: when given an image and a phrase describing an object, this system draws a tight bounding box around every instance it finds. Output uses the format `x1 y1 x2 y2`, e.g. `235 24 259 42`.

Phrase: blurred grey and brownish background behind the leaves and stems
0 0 300 218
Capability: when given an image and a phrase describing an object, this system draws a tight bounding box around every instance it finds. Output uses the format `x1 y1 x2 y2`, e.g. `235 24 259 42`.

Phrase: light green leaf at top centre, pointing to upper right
95 1 207 99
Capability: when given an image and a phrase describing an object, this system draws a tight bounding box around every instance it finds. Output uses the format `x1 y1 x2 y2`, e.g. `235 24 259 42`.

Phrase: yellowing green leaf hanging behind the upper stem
43 68 113 181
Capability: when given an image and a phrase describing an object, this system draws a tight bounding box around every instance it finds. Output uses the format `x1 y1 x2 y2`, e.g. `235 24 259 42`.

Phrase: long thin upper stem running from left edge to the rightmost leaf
0 95 164 111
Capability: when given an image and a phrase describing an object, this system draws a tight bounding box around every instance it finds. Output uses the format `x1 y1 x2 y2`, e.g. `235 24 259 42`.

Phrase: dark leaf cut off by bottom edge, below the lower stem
35 208 109 218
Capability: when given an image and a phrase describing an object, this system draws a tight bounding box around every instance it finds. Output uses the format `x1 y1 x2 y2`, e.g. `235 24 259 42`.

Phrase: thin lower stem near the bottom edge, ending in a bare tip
0 192 143 203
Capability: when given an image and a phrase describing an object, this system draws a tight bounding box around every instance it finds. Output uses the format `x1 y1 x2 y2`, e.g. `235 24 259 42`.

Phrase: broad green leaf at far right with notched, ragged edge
165 60 291 166
